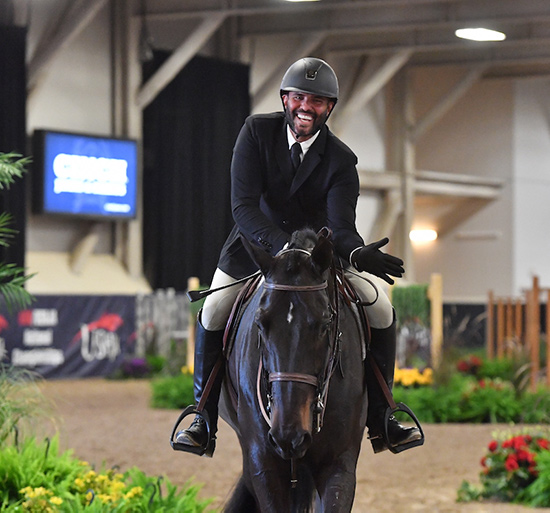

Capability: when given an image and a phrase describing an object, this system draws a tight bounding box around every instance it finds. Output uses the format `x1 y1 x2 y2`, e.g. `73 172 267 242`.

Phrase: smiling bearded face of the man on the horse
283 91 334 142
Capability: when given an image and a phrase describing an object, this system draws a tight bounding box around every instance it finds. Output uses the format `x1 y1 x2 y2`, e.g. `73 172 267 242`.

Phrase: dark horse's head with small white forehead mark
246 230 335 459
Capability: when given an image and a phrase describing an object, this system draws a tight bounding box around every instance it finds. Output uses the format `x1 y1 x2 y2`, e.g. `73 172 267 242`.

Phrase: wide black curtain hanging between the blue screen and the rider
143 53 250 291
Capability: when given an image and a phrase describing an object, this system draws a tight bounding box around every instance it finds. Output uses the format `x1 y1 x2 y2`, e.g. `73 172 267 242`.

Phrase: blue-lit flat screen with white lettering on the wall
32 130 138 220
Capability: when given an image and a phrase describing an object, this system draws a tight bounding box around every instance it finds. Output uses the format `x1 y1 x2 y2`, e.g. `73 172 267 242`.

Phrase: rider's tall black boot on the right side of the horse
366 315 423 453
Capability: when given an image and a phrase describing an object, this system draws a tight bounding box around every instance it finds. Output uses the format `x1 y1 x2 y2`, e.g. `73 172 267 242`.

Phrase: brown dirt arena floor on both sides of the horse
37 379 550 513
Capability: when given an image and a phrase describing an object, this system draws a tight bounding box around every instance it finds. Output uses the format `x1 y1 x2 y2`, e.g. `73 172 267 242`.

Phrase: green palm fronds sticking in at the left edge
0 153 33 312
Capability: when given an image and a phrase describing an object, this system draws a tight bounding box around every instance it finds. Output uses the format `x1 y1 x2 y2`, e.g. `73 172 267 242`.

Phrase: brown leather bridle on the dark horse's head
256 248 340 433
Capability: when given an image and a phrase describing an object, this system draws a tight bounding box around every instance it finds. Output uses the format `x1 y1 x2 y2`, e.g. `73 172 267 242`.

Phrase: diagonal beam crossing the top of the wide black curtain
136 13 226 109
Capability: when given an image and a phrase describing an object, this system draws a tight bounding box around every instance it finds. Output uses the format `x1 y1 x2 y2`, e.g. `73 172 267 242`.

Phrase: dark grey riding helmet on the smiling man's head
280 57 339 103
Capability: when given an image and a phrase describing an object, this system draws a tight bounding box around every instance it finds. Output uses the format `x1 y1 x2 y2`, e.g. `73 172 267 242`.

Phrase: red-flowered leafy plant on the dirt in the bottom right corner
458 429 550 506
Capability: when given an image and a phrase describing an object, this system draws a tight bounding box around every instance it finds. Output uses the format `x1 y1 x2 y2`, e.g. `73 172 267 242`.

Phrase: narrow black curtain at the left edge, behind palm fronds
0 25 27 267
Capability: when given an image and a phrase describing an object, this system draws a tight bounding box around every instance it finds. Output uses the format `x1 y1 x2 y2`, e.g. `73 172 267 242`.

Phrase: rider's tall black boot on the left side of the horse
176 313 224 457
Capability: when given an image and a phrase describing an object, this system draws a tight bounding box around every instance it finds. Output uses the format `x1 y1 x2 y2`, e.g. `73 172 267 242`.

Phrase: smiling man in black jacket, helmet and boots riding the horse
176 57 422 455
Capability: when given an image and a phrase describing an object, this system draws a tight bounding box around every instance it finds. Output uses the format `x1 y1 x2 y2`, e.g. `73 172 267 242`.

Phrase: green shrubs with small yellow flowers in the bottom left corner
0 436 215 513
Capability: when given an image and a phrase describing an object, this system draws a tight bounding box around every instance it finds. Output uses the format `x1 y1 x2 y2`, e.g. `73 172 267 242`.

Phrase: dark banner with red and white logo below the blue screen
0 295 135 378
